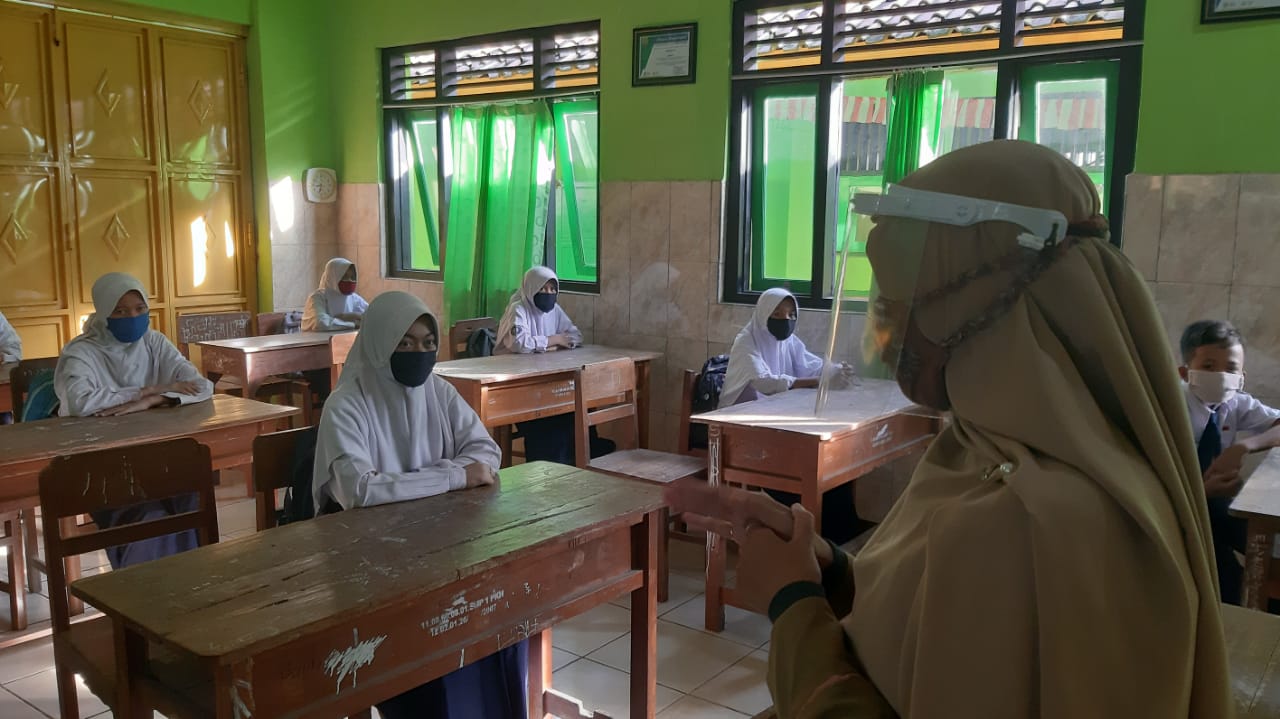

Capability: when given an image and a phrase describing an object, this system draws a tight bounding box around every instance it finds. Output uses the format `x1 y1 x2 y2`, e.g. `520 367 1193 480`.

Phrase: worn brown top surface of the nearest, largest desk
72 462 663 659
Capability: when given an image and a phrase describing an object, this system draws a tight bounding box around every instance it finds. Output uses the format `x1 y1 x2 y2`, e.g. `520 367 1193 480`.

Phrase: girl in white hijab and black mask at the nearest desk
312 292 527 719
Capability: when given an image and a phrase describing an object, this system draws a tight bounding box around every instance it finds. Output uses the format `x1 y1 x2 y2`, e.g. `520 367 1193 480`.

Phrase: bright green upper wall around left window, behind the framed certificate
325 0 731 182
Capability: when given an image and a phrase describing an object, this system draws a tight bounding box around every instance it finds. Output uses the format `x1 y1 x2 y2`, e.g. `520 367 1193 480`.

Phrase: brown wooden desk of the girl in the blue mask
0 394 298 614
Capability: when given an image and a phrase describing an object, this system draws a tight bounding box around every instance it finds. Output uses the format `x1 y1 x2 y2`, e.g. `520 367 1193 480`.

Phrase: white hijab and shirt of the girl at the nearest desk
311 292 502 512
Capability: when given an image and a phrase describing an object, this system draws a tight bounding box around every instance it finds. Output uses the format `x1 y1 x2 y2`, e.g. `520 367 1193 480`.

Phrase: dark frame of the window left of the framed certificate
379 19 604 293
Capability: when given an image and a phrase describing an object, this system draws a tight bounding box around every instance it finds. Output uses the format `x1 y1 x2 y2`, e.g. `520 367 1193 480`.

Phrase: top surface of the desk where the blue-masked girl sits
0 394 298 467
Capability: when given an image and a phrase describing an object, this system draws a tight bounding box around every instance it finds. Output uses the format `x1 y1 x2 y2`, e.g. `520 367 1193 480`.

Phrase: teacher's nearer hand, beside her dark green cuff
733 504 822 614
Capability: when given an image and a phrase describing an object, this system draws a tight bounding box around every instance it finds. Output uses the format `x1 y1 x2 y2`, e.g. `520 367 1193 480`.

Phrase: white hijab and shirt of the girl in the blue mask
54 273 214 417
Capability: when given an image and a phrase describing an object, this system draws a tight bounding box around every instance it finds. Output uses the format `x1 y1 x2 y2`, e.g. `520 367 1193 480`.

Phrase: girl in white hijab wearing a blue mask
54 273 214 569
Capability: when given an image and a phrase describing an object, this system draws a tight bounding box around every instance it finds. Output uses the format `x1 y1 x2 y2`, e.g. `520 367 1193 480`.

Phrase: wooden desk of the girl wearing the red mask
192 333 355 397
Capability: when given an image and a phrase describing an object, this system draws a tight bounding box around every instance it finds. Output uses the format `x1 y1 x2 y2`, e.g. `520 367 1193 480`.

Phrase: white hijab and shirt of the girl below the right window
719 288 824 407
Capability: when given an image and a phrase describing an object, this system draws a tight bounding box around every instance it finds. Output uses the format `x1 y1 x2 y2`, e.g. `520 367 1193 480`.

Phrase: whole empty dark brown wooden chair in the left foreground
40 439 218 719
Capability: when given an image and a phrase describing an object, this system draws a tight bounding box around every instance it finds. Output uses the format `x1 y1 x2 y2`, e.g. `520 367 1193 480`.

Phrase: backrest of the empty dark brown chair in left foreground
40 438 218 632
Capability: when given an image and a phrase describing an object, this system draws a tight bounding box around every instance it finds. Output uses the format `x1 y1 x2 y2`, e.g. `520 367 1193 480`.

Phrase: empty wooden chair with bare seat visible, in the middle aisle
573 357 707 601
